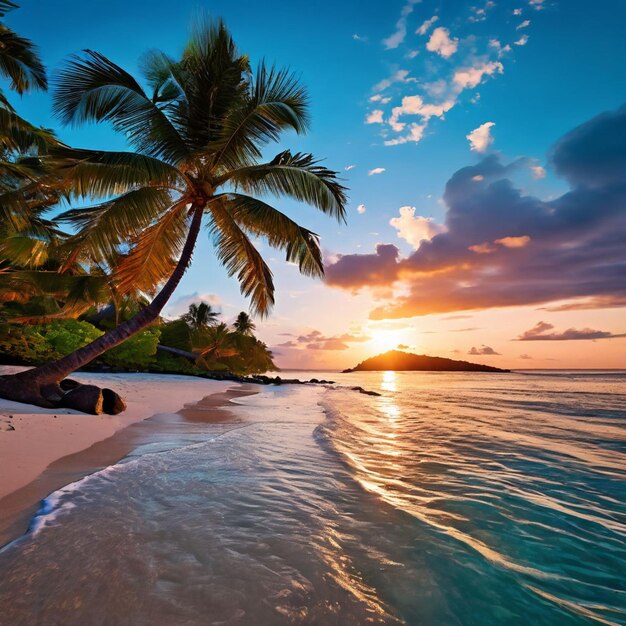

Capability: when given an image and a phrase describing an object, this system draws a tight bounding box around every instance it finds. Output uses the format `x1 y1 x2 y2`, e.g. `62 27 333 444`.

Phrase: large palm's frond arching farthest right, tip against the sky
217 150 347 222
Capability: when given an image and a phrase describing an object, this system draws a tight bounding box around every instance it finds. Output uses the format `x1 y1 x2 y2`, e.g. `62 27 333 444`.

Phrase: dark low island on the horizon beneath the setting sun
342 350 510 374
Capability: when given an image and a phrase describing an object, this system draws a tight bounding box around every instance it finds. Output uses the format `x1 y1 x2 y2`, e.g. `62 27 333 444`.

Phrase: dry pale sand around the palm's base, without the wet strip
0 367 235 499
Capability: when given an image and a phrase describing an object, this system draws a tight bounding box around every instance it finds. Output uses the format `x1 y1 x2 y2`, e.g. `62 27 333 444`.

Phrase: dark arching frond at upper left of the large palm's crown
53 50 188 163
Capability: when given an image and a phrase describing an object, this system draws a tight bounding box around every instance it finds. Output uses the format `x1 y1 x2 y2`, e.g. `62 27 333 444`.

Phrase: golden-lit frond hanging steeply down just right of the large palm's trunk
210 200 274 316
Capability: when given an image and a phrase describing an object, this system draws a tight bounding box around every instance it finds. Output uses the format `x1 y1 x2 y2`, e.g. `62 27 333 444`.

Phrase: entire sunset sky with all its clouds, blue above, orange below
6 0 626 369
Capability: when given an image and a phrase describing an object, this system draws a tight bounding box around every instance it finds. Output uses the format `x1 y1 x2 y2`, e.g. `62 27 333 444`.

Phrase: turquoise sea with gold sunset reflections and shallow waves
0 372 626 626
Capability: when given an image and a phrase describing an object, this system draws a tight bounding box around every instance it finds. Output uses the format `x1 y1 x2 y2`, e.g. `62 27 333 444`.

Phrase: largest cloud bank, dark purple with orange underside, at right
326 106 626 319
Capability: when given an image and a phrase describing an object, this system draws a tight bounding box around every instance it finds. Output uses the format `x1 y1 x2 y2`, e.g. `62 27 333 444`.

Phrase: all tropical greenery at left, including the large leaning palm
0 9 346 406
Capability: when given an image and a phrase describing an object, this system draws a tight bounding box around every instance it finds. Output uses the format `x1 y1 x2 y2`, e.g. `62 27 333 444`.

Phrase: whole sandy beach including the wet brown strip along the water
0 367 253 545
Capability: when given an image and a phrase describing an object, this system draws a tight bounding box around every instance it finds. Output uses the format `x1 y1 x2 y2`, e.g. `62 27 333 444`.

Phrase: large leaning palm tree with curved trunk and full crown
0 22 346 406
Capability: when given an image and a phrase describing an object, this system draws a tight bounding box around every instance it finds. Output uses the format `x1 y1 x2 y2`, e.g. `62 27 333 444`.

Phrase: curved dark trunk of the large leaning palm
0 206 204 407
